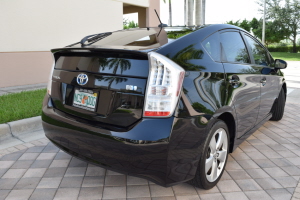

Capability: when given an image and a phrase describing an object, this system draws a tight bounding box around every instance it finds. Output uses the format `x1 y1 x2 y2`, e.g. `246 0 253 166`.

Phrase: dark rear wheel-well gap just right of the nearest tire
218 112 236 153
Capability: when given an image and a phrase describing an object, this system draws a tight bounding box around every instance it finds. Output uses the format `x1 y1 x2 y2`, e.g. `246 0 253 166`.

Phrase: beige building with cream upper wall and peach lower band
0 0 160 87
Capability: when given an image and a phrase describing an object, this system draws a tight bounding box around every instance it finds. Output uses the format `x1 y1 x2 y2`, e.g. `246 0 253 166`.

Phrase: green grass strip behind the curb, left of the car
0 89 46 124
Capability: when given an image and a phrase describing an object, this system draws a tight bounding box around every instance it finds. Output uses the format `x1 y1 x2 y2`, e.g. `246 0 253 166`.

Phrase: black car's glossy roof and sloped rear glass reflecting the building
52 24 244 53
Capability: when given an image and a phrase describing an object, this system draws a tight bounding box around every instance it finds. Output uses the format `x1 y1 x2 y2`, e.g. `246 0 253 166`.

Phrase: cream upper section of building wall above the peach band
0 0 123 52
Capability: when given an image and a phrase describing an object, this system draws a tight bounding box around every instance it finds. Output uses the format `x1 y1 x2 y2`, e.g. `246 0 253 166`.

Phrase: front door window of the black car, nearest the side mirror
245 35 271 66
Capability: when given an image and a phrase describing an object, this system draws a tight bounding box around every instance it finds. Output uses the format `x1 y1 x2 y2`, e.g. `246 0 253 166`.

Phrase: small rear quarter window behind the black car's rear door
202 33 221 61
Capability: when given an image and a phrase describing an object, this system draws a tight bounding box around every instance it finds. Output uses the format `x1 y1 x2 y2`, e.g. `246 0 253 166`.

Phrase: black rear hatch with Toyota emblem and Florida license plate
51 48 149 131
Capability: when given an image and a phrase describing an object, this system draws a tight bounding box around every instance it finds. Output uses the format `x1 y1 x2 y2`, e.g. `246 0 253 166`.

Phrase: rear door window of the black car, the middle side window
221 32 250 63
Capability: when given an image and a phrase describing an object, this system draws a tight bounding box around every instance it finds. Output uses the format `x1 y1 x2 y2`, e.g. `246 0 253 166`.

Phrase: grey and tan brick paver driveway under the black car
0 101 300 200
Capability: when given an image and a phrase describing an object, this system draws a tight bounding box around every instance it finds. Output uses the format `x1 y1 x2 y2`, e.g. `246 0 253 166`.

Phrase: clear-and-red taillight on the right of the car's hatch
144 52 185 117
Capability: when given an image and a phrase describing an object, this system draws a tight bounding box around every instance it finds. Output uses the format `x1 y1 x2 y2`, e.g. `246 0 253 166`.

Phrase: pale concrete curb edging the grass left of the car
0 116 43 146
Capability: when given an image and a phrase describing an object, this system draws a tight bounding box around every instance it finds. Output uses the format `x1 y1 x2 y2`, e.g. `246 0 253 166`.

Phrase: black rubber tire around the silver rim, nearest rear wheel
189 120 230 190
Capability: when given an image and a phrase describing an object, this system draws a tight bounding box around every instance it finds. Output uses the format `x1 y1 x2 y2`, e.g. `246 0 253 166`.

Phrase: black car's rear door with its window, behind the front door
220 30 261 138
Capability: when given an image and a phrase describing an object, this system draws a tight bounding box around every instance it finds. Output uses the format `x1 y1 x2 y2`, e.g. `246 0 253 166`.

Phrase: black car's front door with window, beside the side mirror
243 33 280 124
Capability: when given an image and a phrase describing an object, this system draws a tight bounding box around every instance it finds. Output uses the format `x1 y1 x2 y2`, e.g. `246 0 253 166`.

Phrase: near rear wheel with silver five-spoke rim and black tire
189 120 229 190
